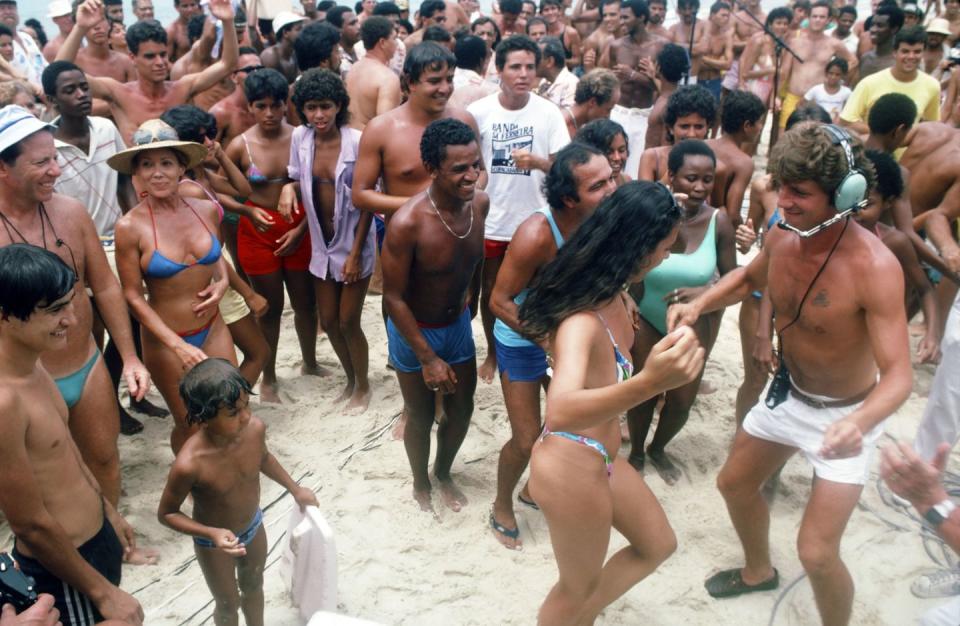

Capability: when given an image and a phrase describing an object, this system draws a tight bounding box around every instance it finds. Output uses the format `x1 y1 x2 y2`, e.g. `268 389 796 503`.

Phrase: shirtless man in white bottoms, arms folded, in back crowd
608 0 667 179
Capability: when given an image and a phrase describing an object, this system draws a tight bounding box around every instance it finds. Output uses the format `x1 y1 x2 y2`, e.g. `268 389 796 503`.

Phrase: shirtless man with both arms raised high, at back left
57 0 238 144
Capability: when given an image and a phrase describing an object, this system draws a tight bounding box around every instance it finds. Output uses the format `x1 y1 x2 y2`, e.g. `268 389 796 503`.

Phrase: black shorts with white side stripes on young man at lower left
13 517 123 626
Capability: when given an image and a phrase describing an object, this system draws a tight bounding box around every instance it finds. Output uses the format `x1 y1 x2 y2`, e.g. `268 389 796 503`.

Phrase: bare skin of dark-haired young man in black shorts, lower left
0 270 143 625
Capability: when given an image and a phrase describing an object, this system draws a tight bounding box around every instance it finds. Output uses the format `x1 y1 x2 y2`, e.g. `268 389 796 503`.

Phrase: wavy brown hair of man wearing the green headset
767 122 876 199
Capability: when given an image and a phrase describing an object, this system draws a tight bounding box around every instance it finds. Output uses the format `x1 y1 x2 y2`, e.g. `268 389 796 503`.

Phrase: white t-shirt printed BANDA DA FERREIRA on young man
467 93 570 241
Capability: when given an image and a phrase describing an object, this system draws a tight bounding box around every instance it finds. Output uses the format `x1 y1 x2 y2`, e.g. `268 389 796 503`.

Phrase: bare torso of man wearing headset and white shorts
765 220 903 398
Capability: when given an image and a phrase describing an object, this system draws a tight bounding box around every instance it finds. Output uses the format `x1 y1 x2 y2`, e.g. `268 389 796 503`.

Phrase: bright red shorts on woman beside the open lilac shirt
237 200 312 276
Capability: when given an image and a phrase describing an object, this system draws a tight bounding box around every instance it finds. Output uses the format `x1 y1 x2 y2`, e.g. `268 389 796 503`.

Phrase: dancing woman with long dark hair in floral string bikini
520 182 703 625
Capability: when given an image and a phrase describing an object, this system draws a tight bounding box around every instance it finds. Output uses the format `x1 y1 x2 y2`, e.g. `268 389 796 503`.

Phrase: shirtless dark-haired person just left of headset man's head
707 91 767 222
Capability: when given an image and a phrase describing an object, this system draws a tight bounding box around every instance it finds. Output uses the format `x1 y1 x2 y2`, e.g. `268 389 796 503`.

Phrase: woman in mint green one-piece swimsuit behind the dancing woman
627 139 737 485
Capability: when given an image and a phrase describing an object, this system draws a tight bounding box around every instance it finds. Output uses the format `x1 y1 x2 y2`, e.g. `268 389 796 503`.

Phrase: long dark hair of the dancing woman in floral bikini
520 181 680 341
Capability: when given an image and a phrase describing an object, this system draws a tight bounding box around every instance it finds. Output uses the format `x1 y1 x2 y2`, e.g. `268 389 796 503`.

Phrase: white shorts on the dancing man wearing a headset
743 380 883 485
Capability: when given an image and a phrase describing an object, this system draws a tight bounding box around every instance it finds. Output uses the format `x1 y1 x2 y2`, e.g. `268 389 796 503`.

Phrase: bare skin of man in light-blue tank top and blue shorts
490 155 616 549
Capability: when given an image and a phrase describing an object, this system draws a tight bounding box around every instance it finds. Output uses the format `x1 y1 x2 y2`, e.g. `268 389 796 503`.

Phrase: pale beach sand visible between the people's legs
7 296 938 626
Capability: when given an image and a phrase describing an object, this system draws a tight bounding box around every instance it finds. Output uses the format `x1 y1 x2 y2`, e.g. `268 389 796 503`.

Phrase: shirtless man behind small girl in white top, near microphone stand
780 0 857 128
